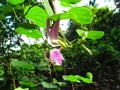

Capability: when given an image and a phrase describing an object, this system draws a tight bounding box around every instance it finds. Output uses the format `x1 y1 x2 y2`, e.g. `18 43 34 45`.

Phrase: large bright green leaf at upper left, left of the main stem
24 6 48 28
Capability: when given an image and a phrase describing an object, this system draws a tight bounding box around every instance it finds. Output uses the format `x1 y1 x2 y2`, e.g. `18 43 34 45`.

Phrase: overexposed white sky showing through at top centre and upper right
54 0 115 30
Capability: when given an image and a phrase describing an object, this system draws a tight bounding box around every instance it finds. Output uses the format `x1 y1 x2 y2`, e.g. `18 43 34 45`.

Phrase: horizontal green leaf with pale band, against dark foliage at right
76 29 104 40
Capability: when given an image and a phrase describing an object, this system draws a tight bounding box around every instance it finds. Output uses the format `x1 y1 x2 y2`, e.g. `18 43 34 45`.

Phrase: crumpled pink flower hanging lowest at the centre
50 49 64 65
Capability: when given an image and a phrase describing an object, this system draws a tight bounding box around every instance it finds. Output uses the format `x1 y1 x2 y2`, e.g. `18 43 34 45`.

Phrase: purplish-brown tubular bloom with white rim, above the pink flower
46 19 60 47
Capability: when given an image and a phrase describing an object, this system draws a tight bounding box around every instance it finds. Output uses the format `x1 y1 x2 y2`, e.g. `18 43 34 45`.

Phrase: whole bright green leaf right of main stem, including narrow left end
51 7 93 24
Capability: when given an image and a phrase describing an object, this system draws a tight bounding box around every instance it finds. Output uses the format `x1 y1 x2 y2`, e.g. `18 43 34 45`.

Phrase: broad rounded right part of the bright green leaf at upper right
68 7 93 24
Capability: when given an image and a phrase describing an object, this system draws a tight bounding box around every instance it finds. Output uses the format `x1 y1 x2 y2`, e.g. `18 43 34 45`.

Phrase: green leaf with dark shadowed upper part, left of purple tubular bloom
16 24 42 39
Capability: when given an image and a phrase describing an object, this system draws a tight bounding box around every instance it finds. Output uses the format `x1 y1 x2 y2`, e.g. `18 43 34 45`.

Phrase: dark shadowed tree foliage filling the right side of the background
64 4 120 90
